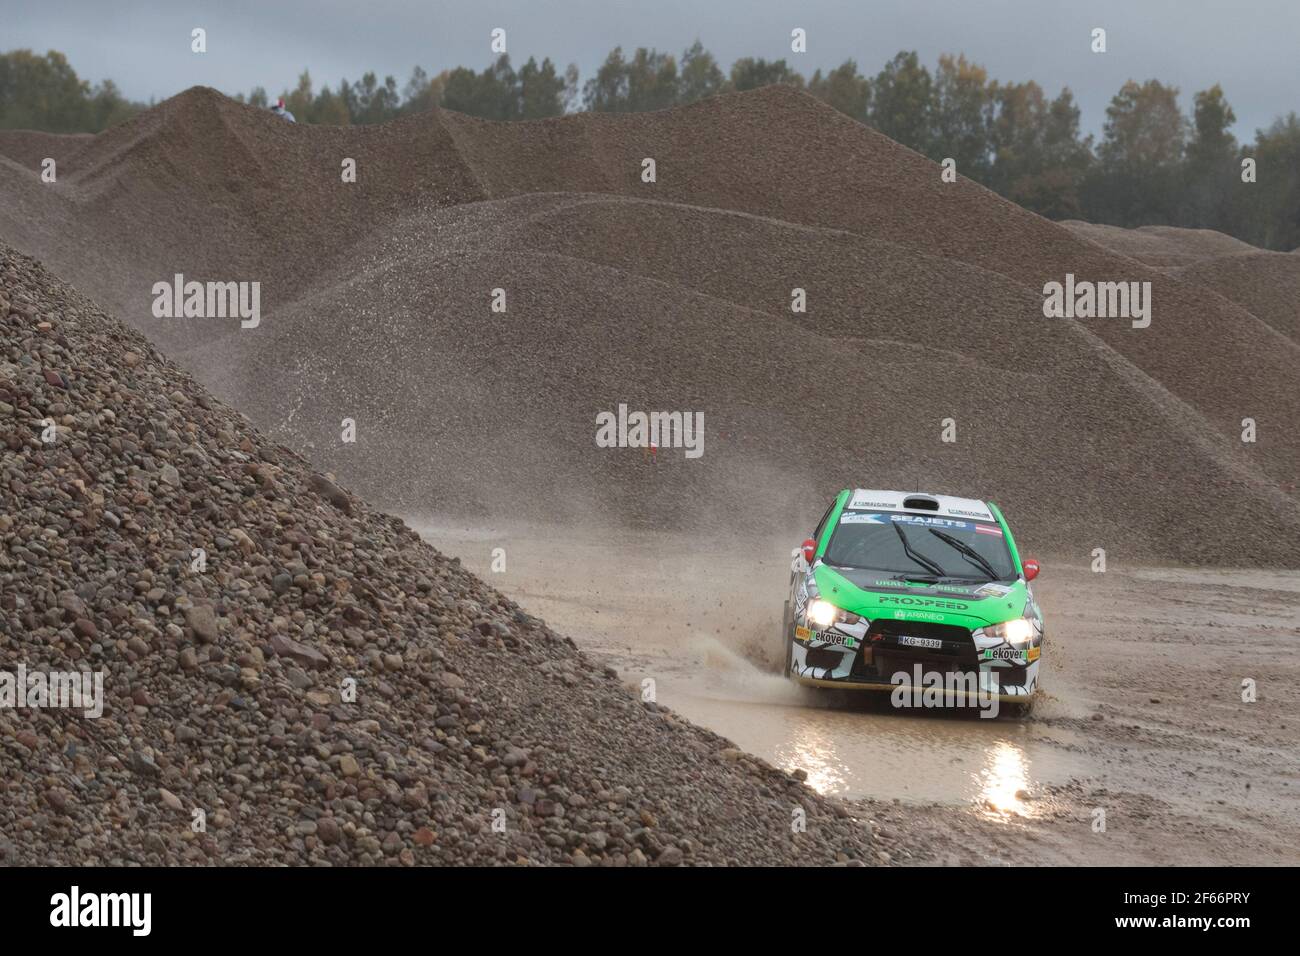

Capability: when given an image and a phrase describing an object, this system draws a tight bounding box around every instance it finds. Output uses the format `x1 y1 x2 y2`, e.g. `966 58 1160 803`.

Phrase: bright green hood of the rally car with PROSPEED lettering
813 563 1028 630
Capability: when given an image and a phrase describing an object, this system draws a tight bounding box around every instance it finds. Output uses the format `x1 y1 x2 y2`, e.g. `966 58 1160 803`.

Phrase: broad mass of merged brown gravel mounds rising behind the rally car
0 87 1300 567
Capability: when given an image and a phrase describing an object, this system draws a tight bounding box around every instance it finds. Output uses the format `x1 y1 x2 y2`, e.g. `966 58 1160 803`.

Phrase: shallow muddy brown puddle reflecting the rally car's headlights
424 515 1089 817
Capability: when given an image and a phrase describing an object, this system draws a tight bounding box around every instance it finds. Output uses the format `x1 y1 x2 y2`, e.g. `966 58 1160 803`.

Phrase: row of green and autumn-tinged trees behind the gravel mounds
0 47 1300 250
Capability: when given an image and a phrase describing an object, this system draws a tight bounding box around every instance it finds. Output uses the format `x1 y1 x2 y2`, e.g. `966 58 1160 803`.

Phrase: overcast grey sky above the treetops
0 0 1300 139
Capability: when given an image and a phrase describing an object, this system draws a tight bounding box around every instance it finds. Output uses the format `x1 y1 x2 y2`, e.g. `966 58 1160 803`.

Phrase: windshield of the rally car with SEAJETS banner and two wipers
822 511 1015 580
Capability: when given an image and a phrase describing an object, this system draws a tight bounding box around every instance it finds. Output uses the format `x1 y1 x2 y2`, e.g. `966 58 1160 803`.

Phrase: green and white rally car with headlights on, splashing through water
781 489 1043 713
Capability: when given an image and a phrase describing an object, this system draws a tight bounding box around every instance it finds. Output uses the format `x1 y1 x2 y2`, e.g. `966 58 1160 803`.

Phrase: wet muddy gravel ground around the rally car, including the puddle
412 518 1300 865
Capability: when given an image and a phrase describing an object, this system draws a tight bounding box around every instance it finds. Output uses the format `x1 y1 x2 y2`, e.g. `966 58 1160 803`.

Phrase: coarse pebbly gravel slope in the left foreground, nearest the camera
0 245 888 865
